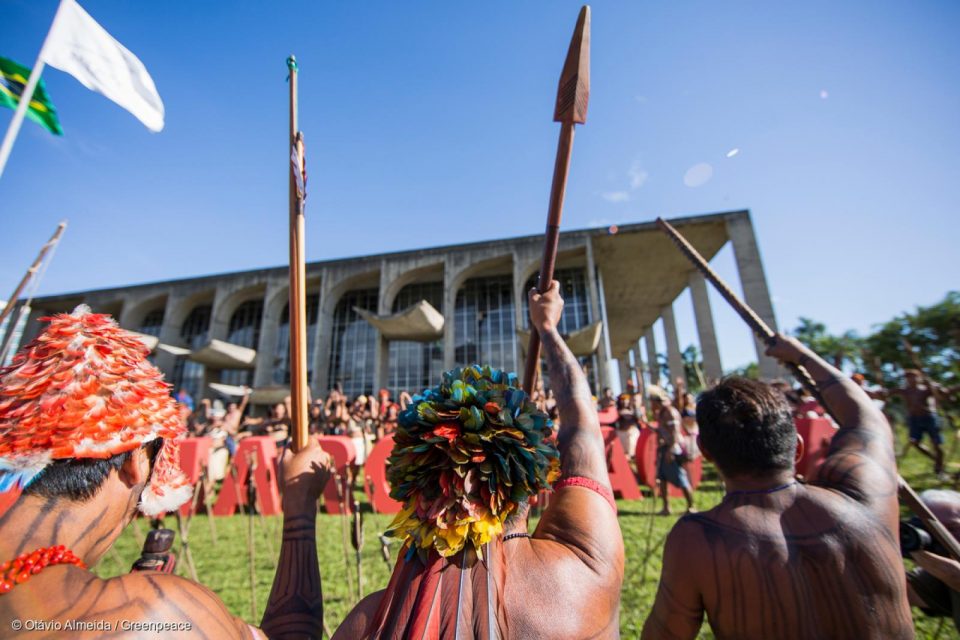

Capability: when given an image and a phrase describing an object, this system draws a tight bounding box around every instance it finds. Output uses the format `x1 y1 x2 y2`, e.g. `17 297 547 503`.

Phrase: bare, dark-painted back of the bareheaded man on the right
664 483 913 639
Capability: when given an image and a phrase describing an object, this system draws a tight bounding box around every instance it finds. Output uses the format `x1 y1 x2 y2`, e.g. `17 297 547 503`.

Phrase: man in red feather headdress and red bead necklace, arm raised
0 308 329 639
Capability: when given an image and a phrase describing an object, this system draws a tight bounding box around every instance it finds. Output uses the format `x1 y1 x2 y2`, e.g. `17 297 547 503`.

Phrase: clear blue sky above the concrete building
0 0 960 368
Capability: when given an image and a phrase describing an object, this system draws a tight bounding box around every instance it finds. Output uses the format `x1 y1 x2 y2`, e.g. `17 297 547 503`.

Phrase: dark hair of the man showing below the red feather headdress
23 438 163 502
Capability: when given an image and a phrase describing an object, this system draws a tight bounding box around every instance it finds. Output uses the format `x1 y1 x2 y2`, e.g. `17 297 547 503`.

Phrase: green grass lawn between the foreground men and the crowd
96 422 960 639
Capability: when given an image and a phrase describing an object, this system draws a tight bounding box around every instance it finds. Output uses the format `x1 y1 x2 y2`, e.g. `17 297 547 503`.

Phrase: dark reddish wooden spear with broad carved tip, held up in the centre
523 5 590 394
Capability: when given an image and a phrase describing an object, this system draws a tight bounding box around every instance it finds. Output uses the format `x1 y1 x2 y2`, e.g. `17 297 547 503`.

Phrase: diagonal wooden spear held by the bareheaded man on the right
657 218 960 560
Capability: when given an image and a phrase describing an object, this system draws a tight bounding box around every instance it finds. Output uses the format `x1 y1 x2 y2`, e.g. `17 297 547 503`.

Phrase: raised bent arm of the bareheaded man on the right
767 334 898 527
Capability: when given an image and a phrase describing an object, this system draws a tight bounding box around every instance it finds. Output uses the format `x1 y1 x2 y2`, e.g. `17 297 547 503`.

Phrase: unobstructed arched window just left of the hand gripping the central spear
453 276 517 371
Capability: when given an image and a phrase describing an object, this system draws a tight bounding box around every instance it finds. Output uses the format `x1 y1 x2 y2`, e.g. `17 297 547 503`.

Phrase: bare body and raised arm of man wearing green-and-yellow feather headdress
334 281 624 640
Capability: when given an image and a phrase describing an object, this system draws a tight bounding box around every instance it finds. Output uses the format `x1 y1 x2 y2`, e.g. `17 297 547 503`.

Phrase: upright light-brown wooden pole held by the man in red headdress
287 56 309 452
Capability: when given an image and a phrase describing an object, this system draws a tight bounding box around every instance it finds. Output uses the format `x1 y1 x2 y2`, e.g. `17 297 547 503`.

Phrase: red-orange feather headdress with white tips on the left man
0 305 191 515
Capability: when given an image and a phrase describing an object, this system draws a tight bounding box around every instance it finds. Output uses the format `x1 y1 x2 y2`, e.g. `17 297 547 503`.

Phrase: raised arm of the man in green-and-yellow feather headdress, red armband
530 281 623 572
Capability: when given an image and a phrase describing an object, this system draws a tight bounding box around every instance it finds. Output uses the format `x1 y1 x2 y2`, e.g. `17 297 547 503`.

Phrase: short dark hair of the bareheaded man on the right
697 376 797 476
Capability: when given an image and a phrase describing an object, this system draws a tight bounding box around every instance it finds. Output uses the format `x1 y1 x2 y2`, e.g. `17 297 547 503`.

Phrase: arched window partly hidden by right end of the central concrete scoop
388 282 443 398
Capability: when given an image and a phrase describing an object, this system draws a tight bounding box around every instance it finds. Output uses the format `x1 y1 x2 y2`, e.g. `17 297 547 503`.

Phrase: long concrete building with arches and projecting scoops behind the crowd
5 211 779 397
